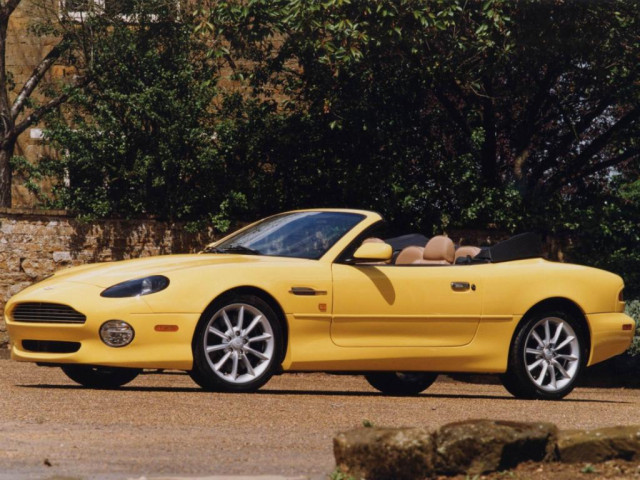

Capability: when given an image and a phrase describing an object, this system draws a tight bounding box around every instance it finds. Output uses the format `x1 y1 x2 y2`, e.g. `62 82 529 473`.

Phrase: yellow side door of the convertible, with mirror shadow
331 263 482 347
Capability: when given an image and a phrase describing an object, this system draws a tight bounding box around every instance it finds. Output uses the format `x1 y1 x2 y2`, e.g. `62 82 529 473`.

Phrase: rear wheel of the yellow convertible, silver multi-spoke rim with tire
501 311 588 400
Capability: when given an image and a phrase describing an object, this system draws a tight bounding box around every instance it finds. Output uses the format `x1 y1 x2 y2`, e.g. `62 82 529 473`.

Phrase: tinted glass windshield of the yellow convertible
205 212 364 259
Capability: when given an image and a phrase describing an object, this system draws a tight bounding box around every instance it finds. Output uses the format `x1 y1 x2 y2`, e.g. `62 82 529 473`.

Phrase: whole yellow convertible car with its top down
5 209 635 399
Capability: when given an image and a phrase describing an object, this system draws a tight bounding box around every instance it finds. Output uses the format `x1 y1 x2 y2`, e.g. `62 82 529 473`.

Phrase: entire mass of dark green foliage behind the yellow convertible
26 0 640 294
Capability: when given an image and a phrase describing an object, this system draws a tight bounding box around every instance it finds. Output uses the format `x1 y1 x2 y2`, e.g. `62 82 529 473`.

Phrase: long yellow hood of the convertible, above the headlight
45 253 305 288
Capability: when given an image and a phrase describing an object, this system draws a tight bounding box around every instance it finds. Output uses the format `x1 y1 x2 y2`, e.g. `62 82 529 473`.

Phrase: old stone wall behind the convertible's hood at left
0 208 213 349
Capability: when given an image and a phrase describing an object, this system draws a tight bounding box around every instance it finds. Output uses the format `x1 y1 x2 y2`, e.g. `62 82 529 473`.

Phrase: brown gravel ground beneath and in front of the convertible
0 359 640 480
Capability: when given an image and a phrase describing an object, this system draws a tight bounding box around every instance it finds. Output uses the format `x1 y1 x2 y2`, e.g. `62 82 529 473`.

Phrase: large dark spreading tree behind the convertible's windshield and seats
199 0 640 231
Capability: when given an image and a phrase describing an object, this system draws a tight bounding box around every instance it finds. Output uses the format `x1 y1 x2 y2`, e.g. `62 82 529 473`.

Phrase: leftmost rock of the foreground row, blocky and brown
333 428 435 480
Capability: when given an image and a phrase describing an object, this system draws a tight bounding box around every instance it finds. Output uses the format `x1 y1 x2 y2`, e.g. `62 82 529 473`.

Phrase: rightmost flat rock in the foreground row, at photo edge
558 425 640 463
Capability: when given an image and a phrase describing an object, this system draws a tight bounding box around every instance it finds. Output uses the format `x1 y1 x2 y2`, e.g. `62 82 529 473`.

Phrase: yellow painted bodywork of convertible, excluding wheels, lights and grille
5 209 633 373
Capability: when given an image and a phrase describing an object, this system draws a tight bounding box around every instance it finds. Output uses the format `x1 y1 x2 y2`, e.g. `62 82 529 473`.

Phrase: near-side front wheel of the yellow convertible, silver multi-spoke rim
189 295 283 392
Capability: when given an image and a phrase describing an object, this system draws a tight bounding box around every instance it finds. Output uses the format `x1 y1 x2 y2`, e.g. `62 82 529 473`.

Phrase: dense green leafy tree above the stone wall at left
30 2 248 229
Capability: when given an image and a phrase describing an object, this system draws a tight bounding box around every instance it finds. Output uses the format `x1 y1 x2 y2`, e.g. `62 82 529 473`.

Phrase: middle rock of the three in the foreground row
435 420 558 475
